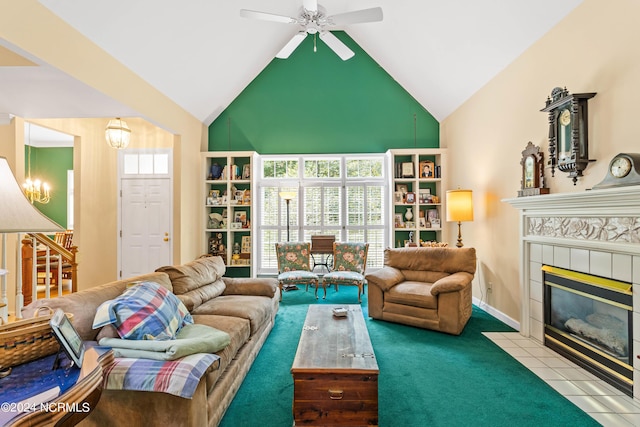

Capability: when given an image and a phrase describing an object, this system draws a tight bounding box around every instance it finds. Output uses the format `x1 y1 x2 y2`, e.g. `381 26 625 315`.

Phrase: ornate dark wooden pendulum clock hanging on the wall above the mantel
540 87 596 185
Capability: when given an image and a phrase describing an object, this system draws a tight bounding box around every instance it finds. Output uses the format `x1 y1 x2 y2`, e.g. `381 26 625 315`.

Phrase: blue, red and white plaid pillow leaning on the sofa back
93 282 193 340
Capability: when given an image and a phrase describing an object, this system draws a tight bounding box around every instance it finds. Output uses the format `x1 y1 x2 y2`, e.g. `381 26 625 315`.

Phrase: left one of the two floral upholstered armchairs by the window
276 242 318 300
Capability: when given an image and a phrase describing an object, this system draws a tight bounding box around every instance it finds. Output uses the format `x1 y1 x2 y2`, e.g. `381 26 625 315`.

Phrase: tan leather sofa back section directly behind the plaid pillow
22 273 172 341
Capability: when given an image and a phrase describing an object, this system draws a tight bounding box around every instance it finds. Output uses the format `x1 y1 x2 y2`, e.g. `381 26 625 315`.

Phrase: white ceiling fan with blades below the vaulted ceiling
240 0 382 61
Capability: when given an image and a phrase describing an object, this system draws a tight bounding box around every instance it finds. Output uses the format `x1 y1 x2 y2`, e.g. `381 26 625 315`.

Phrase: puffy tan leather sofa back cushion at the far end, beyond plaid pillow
156 256 226 311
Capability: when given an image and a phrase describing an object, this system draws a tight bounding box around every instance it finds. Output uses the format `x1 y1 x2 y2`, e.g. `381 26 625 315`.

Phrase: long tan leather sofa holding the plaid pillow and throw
24 257 279 427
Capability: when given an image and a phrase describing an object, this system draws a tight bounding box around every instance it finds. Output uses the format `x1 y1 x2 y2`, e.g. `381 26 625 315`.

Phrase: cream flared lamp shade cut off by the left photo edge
0 157 64 233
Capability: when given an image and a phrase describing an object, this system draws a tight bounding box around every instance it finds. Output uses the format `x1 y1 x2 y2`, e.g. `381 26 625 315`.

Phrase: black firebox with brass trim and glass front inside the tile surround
542 265 633 396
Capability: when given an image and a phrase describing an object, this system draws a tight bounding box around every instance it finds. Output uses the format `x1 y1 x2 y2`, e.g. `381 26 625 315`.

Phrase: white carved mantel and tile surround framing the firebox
503 186 640 402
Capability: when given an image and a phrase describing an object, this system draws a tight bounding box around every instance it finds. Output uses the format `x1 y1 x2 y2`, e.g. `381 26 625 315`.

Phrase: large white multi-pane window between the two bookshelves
257 155 389 274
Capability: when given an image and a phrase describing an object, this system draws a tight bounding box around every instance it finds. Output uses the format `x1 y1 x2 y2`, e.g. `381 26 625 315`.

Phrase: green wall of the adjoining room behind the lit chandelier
24 146 73 228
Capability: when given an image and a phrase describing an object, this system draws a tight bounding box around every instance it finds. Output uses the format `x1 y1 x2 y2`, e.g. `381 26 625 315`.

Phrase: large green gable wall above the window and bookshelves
209 31 440 154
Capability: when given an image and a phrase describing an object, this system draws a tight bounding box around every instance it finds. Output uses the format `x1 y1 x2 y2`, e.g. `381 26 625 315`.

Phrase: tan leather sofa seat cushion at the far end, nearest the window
192 295 273 334
